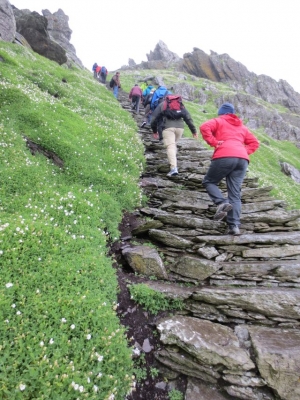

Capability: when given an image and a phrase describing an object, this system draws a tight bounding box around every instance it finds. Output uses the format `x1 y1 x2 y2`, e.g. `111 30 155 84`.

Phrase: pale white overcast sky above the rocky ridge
10 0 300 93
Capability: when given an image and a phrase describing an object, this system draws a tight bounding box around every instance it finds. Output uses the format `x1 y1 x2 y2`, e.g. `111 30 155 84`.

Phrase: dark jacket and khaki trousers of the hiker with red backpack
151 101 198 177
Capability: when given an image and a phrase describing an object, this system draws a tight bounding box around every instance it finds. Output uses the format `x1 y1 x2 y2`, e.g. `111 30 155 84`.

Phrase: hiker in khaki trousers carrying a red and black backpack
151 92 198 176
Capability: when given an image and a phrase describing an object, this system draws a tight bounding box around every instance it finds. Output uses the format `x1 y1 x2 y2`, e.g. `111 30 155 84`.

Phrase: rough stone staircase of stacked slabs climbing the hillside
119 91 300 400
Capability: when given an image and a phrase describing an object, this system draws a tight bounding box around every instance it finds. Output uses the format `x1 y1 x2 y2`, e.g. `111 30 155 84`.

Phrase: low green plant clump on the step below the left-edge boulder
128 284 183 315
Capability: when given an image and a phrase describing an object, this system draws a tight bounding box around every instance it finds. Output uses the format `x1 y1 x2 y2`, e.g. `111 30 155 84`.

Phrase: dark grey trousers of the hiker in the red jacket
202 157 248 226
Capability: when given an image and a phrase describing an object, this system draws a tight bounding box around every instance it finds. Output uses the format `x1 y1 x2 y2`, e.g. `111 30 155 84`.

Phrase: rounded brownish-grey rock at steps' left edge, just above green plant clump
122 246 168 279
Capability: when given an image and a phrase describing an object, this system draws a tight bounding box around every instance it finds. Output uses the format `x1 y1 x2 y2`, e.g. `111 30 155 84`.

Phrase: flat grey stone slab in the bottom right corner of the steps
249 327 300 400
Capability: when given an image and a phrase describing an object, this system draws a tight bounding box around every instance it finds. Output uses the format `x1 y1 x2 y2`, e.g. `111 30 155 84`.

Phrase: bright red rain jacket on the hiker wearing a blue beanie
200 114 259 161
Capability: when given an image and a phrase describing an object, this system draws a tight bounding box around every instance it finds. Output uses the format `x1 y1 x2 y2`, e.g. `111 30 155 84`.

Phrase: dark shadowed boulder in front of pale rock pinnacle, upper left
14 10 67 65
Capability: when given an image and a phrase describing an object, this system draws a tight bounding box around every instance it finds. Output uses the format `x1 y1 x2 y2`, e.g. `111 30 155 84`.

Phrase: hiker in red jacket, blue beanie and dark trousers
200 103 259 235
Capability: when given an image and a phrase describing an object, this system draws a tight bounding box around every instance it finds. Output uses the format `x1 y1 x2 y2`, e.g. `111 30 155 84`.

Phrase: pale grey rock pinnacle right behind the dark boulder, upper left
42 9 83 68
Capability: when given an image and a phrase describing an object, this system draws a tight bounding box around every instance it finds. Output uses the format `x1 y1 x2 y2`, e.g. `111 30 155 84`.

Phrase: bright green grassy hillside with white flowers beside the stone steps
0 42 300 400
